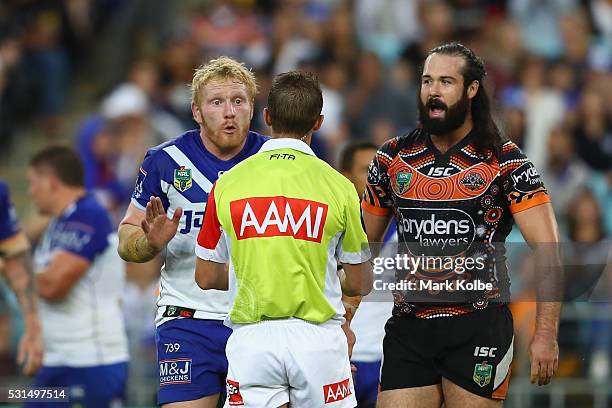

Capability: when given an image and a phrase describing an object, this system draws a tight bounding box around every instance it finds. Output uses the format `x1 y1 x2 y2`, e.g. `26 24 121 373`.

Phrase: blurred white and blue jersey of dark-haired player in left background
34 194 128 367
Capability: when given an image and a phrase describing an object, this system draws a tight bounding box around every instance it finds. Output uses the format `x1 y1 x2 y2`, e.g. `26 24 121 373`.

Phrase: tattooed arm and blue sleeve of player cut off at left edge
0 181 43 375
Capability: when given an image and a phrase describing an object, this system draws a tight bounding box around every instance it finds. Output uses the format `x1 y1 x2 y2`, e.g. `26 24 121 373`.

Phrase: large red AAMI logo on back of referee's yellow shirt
230 196 328 242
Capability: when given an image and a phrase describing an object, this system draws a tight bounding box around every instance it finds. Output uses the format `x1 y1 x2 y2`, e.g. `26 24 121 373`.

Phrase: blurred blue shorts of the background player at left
23 363 128 408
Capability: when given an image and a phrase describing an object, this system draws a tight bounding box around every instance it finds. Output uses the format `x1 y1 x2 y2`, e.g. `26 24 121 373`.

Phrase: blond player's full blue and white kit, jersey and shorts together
132 130 268 404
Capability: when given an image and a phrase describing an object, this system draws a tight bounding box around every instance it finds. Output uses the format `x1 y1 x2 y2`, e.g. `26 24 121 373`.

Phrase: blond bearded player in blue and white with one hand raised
119 57 266 408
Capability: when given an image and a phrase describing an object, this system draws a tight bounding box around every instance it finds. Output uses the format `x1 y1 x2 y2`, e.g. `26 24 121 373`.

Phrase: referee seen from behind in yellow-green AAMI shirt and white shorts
196 72 372 407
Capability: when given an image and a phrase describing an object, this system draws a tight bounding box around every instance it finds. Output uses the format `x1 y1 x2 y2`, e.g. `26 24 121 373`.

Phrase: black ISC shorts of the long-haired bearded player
380 306 514 400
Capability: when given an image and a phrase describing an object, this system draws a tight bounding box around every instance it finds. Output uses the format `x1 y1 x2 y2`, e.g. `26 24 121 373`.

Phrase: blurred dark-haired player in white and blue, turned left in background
28 147 128 407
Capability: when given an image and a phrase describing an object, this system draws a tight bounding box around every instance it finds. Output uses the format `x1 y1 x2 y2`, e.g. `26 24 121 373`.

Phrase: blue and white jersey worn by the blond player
132 130 268 326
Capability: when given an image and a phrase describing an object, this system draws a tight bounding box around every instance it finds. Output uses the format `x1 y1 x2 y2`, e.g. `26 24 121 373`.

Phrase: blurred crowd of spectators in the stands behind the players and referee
0 0 612 404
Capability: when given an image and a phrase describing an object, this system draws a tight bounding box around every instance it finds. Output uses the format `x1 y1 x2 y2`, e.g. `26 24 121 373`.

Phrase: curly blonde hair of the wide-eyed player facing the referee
191 57 257 106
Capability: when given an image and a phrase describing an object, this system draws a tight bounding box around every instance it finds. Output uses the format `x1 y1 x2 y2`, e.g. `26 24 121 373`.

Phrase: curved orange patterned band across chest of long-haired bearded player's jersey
389 156 499 201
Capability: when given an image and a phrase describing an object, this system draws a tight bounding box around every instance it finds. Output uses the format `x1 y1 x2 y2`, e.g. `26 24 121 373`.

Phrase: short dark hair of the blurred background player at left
30 146 85 187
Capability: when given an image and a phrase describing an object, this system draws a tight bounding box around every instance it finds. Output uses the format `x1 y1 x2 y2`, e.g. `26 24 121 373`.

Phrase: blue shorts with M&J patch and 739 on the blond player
155 319 232 405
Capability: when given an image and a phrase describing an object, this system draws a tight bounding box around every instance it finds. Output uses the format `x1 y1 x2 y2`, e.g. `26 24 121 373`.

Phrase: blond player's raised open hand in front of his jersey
141 197 183 251
